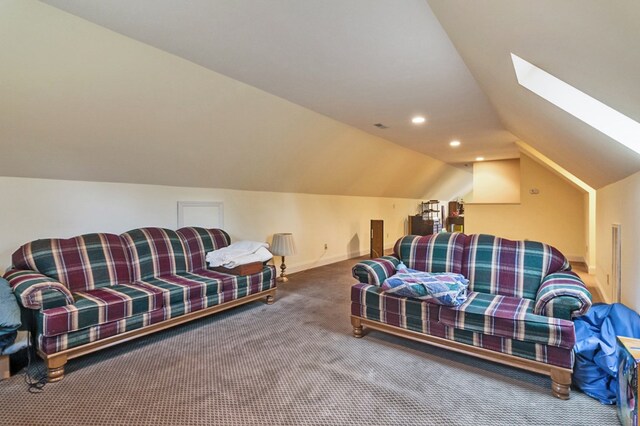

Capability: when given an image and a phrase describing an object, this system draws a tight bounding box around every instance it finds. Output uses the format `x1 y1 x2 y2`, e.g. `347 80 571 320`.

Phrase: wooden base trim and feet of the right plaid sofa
351 315 573 399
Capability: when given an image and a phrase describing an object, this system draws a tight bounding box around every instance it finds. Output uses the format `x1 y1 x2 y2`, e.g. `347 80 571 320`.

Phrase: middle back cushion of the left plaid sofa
121 228 187 280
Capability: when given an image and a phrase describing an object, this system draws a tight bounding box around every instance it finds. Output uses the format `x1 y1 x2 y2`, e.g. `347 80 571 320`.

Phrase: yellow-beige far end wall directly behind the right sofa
465 154 586 260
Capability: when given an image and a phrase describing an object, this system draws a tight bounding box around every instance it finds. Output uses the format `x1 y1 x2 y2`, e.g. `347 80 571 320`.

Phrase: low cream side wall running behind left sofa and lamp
0 177 436 272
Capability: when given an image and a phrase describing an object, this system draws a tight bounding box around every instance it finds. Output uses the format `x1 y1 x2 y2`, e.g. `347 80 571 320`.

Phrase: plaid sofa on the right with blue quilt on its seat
351 233 591 399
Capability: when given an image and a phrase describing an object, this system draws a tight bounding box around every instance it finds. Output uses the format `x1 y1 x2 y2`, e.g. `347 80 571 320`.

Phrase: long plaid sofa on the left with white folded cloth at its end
4 227 276 381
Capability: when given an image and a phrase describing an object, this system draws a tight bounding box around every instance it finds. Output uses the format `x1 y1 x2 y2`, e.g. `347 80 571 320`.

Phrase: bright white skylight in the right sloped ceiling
511 53 640 153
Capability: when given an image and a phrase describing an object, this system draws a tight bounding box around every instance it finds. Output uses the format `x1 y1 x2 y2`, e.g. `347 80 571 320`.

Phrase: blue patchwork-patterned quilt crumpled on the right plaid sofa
381 263 469 306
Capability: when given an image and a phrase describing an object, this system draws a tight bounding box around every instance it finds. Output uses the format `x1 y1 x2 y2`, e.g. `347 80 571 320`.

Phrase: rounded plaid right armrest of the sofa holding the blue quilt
533 271 591 320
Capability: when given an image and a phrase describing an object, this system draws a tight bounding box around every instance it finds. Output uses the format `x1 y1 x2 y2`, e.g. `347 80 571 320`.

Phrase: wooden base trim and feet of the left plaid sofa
38 287 276 382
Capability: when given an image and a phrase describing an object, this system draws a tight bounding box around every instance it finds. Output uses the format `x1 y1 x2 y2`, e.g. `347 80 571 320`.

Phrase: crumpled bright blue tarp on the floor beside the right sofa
573 303 640 404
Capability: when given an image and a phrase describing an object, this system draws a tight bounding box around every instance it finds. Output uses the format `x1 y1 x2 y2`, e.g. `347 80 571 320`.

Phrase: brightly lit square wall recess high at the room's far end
471 159 520 203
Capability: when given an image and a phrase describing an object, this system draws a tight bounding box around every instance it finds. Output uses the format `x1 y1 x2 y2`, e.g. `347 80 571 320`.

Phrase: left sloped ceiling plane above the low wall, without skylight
0 0 471 199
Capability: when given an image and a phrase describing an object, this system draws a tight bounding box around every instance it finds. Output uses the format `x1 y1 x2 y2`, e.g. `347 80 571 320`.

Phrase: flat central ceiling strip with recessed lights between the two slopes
37 0 518 163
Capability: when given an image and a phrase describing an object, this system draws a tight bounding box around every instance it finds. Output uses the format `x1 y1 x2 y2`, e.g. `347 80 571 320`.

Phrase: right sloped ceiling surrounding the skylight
429 0 640 188
